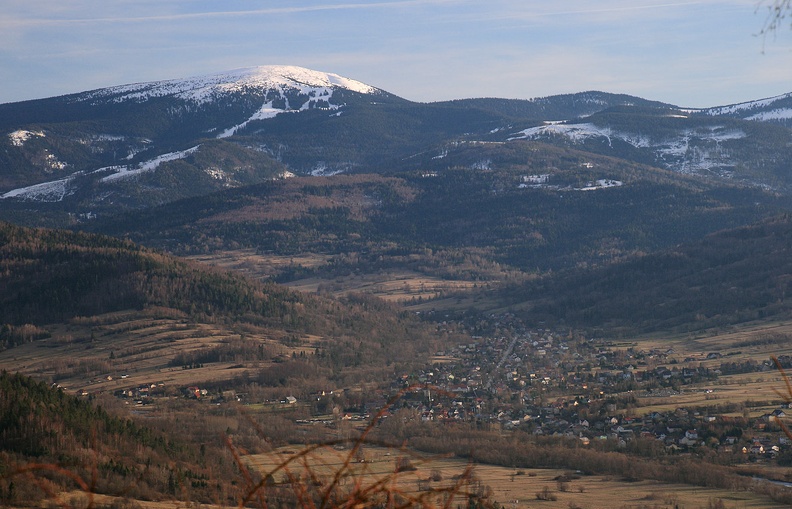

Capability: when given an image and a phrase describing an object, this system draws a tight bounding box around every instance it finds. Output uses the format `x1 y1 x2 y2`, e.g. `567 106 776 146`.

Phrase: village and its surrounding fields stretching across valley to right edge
106 314 792 464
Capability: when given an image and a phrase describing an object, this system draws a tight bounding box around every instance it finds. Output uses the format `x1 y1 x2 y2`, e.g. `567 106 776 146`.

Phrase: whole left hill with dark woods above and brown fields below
0 223 454 390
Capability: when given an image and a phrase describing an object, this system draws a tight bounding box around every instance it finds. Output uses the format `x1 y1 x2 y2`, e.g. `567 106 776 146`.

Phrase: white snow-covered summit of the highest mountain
78 65 377 104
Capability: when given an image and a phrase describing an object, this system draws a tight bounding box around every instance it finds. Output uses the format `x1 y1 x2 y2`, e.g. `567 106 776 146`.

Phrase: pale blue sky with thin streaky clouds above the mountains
0 0 792 108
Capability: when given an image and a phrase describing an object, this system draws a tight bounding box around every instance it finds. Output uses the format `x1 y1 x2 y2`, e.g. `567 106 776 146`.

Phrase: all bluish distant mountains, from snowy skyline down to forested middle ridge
0 66 792 334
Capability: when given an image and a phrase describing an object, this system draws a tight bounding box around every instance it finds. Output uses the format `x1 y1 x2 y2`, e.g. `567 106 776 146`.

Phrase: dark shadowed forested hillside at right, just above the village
501 215 792 336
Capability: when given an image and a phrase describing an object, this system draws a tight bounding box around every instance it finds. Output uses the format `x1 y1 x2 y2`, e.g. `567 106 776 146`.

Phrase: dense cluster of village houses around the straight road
372 316 790 458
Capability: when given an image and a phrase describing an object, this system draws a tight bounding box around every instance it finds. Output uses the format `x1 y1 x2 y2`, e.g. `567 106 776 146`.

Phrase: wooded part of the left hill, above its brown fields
0 218 448 379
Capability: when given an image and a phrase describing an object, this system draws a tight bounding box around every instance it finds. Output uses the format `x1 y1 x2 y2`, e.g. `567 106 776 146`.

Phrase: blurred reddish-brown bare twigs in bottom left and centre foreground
0 384 494 509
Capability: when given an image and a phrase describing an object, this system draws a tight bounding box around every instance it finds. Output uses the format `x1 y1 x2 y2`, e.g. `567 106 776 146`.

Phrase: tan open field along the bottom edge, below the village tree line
245 446 785 509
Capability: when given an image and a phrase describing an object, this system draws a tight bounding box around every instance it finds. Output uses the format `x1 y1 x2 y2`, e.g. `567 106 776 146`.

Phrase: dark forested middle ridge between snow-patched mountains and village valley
92 142 784 274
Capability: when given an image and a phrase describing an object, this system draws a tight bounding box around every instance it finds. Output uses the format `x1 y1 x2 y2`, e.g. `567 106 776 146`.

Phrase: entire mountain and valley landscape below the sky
0 66 792 509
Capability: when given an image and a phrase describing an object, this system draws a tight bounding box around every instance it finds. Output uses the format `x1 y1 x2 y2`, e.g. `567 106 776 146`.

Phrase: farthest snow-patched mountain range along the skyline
0 66 792 225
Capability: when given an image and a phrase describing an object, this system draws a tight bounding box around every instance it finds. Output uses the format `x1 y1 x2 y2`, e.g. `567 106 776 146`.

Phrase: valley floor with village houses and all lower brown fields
0 300 792 507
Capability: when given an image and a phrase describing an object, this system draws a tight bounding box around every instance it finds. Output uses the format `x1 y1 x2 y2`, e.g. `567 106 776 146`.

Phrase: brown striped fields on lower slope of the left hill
0 311 318 393
